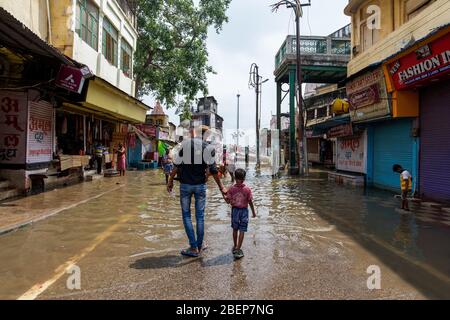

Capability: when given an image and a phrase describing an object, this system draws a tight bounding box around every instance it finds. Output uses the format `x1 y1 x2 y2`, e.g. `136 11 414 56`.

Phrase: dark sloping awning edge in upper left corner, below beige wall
0 7 75 66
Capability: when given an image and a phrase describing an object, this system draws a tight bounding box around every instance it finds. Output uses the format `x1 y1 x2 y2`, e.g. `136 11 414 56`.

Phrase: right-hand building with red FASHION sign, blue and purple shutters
345 0 450 201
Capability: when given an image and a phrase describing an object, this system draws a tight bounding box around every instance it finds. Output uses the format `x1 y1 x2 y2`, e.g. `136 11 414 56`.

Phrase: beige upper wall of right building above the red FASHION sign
345 0 450 77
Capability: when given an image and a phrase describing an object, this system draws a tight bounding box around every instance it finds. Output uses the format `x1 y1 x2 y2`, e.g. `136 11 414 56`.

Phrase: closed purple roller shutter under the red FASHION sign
420 81 450 201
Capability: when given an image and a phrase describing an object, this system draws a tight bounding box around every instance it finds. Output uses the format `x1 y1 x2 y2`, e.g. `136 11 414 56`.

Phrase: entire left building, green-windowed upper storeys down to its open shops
0 0 149 198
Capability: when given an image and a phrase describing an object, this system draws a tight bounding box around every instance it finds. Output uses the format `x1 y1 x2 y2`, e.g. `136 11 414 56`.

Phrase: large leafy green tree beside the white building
135 0 231 113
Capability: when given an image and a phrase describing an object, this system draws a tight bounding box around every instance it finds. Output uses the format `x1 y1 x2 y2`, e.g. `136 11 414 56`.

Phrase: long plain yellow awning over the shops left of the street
82 77 151 124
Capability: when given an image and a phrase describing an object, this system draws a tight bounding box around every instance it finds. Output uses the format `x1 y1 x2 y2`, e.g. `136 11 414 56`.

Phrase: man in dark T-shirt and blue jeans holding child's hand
167 128 227 257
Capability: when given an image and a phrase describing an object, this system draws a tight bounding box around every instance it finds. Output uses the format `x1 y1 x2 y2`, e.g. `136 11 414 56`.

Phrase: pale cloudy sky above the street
144 0 350 144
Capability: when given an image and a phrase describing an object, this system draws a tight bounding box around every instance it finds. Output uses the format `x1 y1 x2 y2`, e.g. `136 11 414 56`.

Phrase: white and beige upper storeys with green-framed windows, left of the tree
0 0 137 97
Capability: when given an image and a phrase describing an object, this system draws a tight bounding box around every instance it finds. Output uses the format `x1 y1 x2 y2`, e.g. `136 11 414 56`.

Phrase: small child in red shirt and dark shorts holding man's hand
226 169 256 259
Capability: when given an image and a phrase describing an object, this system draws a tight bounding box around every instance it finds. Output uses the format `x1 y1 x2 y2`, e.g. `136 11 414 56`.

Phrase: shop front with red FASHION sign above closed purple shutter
384 27 450 202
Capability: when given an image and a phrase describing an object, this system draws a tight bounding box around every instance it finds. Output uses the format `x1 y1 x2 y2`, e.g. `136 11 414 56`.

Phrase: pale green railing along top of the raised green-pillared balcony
275 35 351 69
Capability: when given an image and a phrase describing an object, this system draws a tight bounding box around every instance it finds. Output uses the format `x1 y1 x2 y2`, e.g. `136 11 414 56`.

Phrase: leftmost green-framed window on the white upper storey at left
75 0 99 51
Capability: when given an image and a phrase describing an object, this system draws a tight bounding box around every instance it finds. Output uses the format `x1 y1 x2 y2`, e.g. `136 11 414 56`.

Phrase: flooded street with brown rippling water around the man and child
0 171 450 299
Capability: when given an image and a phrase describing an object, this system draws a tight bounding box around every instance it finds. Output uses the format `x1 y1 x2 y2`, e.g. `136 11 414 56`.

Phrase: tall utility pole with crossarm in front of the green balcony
272 0 311 175
